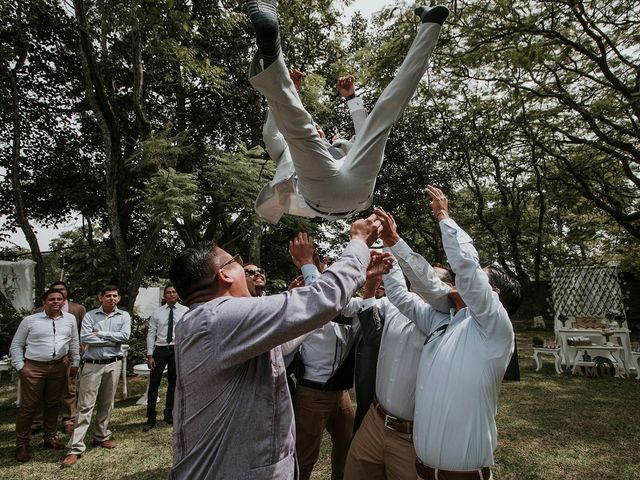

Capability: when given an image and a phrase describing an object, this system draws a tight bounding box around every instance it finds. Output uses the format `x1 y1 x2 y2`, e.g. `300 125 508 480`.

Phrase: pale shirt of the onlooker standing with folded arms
80 307 131 360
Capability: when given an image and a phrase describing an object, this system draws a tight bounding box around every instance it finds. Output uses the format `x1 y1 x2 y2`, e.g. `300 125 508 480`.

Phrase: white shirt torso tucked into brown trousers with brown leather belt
363 298 426 421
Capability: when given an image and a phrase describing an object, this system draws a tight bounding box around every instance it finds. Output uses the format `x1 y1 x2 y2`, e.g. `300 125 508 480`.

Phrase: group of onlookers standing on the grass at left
10 282 187 467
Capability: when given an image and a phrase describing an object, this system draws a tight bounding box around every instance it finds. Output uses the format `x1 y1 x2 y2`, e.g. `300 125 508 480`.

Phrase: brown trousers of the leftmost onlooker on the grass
16 357 67 446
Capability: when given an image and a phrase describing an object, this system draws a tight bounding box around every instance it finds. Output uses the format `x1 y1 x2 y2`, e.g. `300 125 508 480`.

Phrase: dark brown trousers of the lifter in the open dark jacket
293 385 356 480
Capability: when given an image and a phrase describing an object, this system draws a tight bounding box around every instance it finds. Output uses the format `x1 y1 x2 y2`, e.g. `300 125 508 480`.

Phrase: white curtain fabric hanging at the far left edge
0 260 36 313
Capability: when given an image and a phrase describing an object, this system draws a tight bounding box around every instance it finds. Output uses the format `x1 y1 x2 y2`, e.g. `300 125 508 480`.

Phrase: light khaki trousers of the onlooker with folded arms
67 360 122 455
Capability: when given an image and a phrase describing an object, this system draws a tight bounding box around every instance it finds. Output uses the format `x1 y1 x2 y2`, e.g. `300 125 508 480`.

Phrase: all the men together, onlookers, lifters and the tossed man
7 0 521 480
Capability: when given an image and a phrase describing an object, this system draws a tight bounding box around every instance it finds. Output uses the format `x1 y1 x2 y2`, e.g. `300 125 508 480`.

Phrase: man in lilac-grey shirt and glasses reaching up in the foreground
169 216 389 480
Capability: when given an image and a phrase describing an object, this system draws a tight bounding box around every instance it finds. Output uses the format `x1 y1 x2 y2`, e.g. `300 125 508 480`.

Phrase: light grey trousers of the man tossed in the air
249 23 441 214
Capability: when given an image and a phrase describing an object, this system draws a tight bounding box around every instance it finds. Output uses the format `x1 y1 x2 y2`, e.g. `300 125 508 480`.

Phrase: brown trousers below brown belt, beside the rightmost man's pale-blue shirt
344 405 418 480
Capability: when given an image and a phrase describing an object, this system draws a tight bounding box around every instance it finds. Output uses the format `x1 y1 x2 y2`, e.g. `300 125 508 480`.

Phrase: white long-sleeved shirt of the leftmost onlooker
10 311 80 370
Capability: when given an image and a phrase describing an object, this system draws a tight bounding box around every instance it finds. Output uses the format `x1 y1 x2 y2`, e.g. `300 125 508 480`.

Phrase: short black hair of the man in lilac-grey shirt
169 242 217 300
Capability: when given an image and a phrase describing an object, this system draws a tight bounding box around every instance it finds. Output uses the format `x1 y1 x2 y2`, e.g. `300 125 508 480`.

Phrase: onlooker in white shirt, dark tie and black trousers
142 285 189 432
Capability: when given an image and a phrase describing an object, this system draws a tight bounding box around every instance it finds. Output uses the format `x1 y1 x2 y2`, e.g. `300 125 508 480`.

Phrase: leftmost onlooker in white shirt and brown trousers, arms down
10 288 80 462
